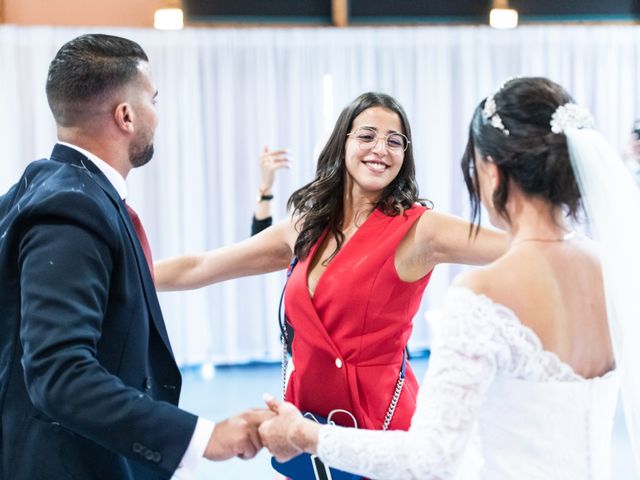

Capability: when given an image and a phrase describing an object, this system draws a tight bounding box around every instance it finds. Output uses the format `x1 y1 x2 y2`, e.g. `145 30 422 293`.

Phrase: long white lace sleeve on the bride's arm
318 288 508 480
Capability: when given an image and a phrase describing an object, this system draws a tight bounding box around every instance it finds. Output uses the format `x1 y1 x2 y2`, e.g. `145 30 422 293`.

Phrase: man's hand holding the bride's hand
204 410 275 461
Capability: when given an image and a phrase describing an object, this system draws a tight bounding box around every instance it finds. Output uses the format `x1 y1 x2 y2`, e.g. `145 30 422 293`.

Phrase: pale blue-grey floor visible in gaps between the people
181 359 636 480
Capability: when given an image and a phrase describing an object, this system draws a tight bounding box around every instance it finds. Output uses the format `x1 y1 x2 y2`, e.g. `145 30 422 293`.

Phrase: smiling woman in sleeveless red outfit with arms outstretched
155 93 507 430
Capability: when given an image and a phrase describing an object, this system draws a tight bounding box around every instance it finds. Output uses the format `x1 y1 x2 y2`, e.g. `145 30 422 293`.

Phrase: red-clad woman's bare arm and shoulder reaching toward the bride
396 210 509 281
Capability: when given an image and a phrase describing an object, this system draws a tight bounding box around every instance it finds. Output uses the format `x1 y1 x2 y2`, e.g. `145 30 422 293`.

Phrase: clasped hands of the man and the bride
204 396 319 462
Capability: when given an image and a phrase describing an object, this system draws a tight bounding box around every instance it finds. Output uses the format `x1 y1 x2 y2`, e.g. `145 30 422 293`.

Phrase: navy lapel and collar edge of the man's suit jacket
51 144 173 357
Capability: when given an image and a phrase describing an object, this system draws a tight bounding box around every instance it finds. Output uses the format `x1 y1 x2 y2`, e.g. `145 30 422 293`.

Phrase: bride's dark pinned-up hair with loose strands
461 77 581 232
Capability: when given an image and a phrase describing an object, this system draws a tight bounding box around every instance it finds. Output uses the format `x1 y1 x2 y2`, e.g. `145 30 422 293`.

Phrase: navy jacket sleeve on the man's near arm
19 194 197 478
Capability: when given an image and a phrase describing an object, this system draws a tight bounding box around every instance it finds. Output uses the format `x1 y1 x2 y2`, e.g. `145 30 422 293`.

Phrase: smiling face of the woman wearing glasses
345 107 404 200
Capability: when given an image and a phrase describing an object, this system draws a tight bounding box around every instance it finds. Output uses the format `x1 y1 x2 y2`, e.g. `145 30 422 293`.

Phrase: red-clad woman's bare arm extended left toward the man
154 218 298 291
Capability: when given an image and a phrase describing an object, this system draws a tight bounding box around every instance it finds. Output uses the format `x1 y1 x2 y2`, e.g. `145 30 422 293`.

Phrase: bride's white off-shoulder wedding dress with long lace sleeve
318 288 618 480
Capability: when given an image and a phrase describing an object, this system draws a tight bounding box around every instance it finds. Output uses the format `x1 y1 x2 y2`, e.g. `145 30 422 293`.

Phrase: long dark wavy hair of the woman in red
287 92 418 259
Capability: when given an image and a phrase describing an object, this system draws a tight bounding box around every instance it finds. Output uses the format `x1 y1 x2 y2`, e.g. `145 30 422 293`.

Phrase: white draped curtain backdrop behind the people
0 26 640 365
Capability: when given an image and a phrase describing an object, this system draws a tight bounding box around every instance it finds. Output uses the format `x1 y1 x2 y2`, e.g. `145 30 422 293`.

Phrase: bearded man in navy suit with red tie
0 35 268 480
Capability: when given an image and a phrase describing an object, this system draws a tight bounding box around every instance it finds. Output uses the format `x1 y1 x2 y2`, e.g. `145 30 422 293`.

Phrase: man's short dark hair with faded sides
46 34 148 126
